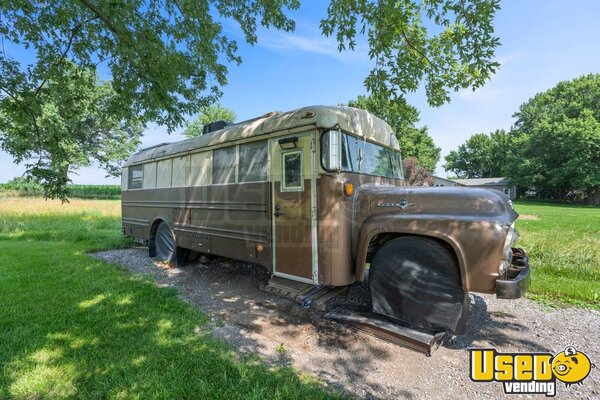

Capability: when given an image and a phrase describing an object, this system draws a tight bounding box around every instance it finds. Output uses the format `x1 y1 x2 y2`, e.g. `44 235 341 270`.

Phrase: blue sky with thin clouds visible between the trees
0 0 600 184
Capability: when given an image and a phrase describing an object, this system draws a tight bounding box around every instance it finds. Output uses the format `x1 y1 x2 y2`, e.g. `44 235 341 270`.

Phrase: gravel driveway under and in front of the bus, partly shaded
94 248 600 399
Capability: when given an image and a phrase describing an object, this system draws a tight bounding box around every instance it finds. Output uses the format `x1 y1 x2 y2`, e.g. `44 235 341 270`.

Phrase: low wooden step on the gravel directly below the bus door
260 277 346 311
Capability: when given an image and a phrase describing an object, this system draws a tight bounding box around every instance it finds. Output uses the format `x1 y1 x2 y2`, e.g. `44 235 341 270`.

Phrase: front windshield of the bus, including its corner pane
321 131 403 179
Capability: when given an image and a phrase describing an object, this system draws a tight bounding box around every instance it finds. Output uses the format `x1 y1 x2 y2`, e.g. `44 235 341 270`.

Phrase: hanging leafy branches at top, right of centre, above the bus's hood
321 0 500 106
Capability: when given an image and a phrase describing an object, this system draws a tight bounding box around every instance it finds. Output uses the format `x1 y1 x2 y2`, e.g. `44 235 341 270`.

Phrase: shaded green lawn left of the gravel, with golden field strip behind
0 197 338 399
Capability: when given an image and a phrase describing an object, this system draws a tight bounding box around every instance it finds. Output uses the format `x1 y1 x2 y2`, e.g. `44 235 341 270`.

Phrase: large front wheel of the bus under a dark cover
369 236 468 334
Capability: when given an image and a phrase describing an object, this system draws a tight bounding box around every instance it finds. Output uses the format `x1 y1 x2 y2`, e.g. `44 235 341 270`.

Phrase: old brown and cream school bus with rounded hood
122 106 530 333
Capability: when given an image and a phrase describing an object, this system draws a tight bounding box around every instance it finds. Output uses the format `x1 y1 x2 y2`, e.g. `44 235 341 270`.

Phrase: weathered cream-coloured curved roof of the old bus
123 106 400 167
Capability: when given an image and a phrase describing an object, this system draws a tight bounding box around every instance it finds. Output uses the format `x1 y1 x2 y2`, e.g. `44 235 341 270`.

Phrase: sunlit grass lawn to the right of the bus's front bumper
515 202 600 310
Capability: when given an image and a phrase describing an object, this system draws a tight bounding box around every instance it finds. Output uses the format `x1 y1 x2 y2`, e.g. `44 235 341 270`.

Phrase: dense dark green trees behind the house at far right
444 74 600 205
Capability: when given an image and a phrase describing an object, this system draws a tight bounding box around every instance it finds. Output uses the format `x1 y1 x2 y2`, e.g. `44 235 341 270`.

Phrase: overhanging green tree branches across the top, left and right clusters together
0 0 499 197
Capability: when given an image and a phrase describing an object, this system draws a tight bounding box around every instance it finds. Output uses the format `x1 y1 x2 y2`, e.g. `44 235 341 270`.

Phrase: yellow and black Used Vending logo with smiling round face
469 346 596 397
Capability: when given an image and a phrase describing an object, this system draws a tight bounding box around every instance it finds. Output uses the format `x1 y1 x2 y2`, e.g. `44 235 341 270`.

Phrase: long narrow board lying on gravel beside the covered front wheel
325 306 445 357
